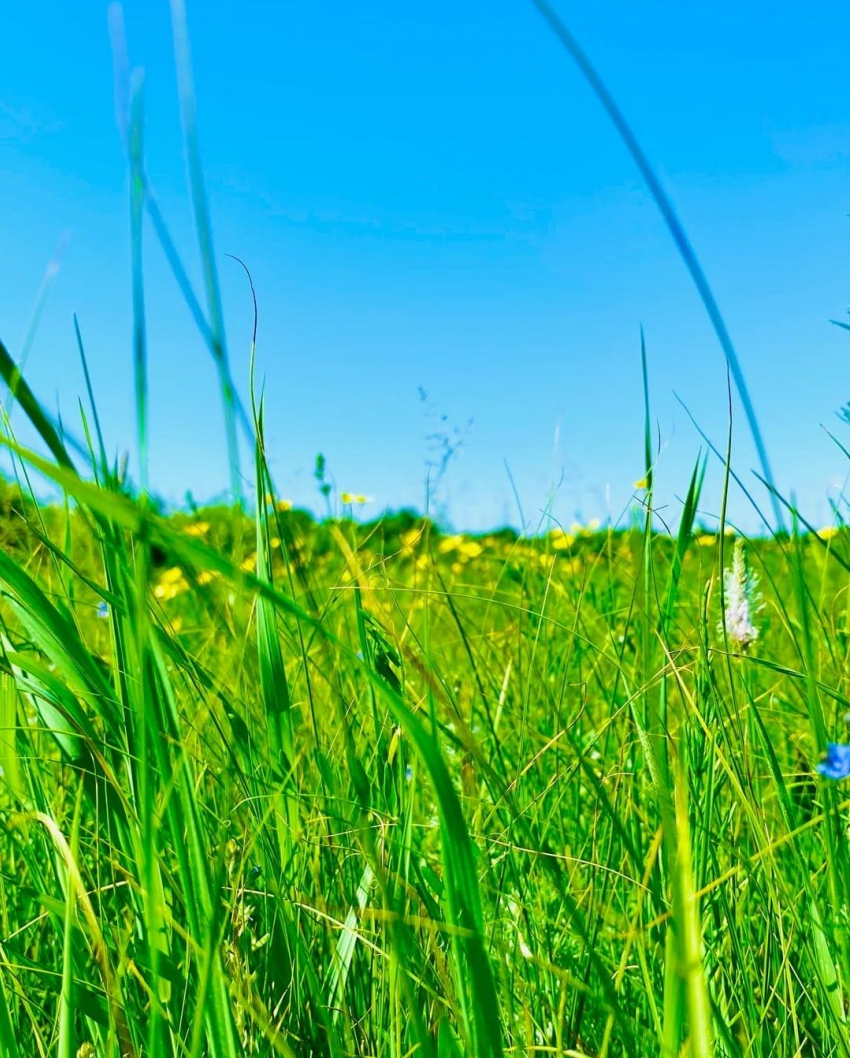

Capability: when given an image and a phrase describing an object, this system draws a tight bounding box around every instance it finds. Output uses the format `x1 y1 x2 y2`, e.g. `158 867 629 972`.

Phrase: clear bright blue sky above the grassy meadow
0 0 850 528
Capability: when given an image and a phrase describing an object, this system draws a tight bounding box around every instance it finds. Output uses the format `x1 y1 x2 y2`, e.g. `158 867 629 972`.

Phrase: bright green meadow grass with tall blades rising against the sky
0 0 850 1058
